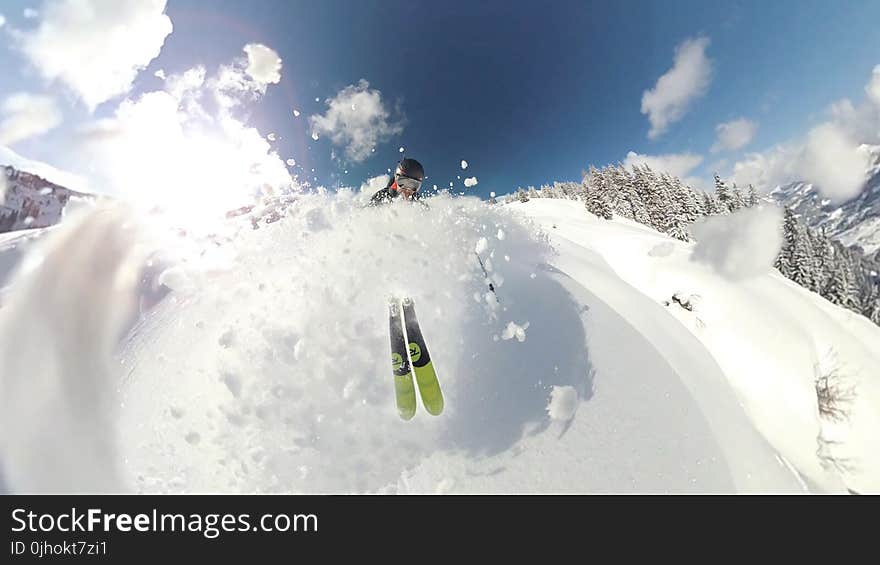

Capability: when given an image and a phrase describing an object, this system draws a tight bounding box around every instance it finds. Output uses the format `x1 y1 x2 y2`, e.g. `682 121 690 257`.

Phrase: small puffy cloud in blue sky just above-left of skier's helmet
309 79 403 162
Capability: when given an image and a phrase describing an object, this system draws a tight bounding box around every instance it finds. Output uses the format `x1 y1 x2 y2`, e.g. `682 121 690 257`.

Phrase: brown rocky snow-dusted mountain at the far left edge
0 165 93 233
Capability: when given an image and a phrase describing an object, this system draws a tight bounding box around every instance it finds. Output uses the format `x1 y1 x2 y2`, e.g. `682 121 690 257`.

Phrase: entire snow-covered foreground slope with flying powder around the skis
0 192 880 493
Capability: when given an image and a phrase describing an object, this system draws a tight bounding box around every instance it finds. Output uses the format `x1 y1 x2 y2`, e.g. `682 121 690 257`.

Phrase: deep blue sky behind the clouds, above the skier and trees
0 0 880 196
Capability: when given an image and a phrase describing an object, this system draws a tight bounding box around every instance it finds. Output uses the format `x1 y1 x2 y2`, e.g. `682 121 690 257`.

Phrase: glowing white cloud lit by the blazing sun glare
75 46 293 229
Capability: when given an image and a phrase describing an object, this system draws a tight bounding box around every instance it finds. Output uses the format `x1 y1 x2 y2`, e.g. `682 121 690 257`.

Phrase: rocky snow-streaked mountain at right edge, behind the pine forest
770 146 880 264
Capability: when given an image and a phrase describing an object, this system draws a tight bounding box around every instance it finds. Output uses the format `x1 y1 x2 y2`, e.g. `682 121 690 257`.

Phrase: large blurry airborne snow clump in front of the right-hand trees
691 206 782 282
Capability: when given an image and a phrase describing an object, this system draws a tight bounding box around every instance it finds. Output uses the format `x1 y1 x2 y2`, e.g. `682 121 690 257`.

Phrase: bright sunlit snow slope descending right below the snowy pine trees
510 199 880 492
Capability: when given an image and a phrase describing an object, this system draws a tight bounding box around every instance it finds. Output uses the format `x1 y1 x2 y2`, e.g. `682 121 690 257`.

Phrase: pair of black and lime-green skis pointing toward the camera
388 297 443 420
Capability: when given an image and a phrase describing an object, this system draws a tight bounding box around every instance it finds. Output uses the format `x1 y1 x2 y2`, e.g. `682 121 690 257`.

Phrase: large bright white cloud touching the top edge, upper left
16 0 172 109
